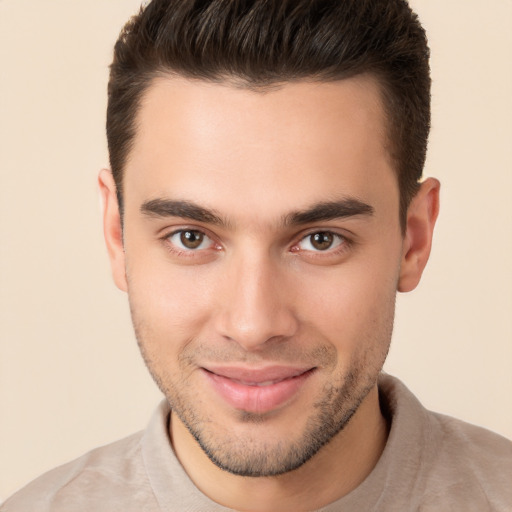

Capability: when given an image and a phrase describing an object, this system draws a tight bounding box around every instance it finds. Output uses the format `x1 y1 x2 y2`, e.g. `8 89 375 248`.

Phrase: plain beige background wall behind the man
0 0 512 498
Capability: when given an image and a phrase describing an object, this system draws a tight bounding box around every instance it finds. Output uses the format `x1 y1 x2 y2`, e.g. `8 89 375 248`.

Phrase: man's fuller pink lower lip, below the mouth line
203 370 314 414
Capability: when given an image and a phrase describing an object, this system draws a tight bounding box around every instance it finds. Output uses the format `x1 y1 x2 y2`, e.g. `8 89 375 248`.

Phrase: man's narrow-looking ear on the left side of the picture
98 169 128 291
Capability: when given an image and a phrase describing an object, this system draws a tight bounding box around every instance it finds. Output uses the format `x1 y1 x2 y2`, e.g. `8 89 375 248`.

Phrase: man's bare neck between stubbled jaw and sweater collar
170 386 388 512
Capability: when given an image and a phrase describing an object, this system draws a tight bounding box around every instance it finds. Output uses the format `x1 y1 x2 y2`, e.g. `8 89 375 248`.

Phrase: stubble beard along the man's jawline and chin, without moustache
134 342 387 477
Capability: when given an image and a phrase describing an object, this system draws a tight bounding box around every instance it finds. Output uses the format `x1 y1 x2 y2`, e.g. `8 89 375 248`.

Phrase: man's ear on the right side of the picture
398 178 441 292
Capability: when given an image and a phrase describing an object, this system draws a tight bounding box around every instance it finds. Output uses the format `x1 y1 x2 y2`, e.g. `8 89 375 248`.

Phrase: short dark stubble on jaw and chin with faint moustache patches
132 301 394 477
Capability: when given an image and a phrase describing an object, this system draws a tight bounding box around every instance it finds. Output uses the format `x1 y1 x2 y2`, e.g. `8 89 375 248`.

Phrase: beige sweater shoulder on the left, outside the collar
0 432 158 512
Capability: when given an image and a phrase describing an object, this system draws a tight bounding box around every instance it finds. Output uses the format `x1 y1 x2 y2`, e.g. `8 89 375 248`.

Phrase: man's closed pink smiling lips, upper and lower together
202 366 315 414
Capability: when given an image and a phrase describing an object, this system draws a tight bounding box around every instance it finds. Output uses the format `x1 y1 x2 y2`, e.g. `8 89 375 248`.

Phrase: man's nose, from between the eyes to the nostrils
216 249 298 351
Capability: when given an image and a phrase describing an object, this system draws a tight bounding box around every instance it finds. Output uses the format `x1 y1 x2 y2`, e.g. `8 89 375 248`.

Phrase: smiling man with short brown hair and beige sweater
2 0 512 511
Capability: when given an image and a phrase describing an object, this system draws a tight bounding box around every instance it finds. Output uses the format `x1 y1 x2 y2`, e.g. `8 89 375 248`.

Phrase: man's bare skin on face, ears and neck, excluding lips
99 76 439 511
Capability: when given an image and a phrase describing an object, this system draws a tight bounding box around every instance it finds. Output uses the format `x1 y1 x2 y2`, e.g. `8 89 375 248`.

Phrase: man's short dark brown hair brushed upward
107 0 430 228
